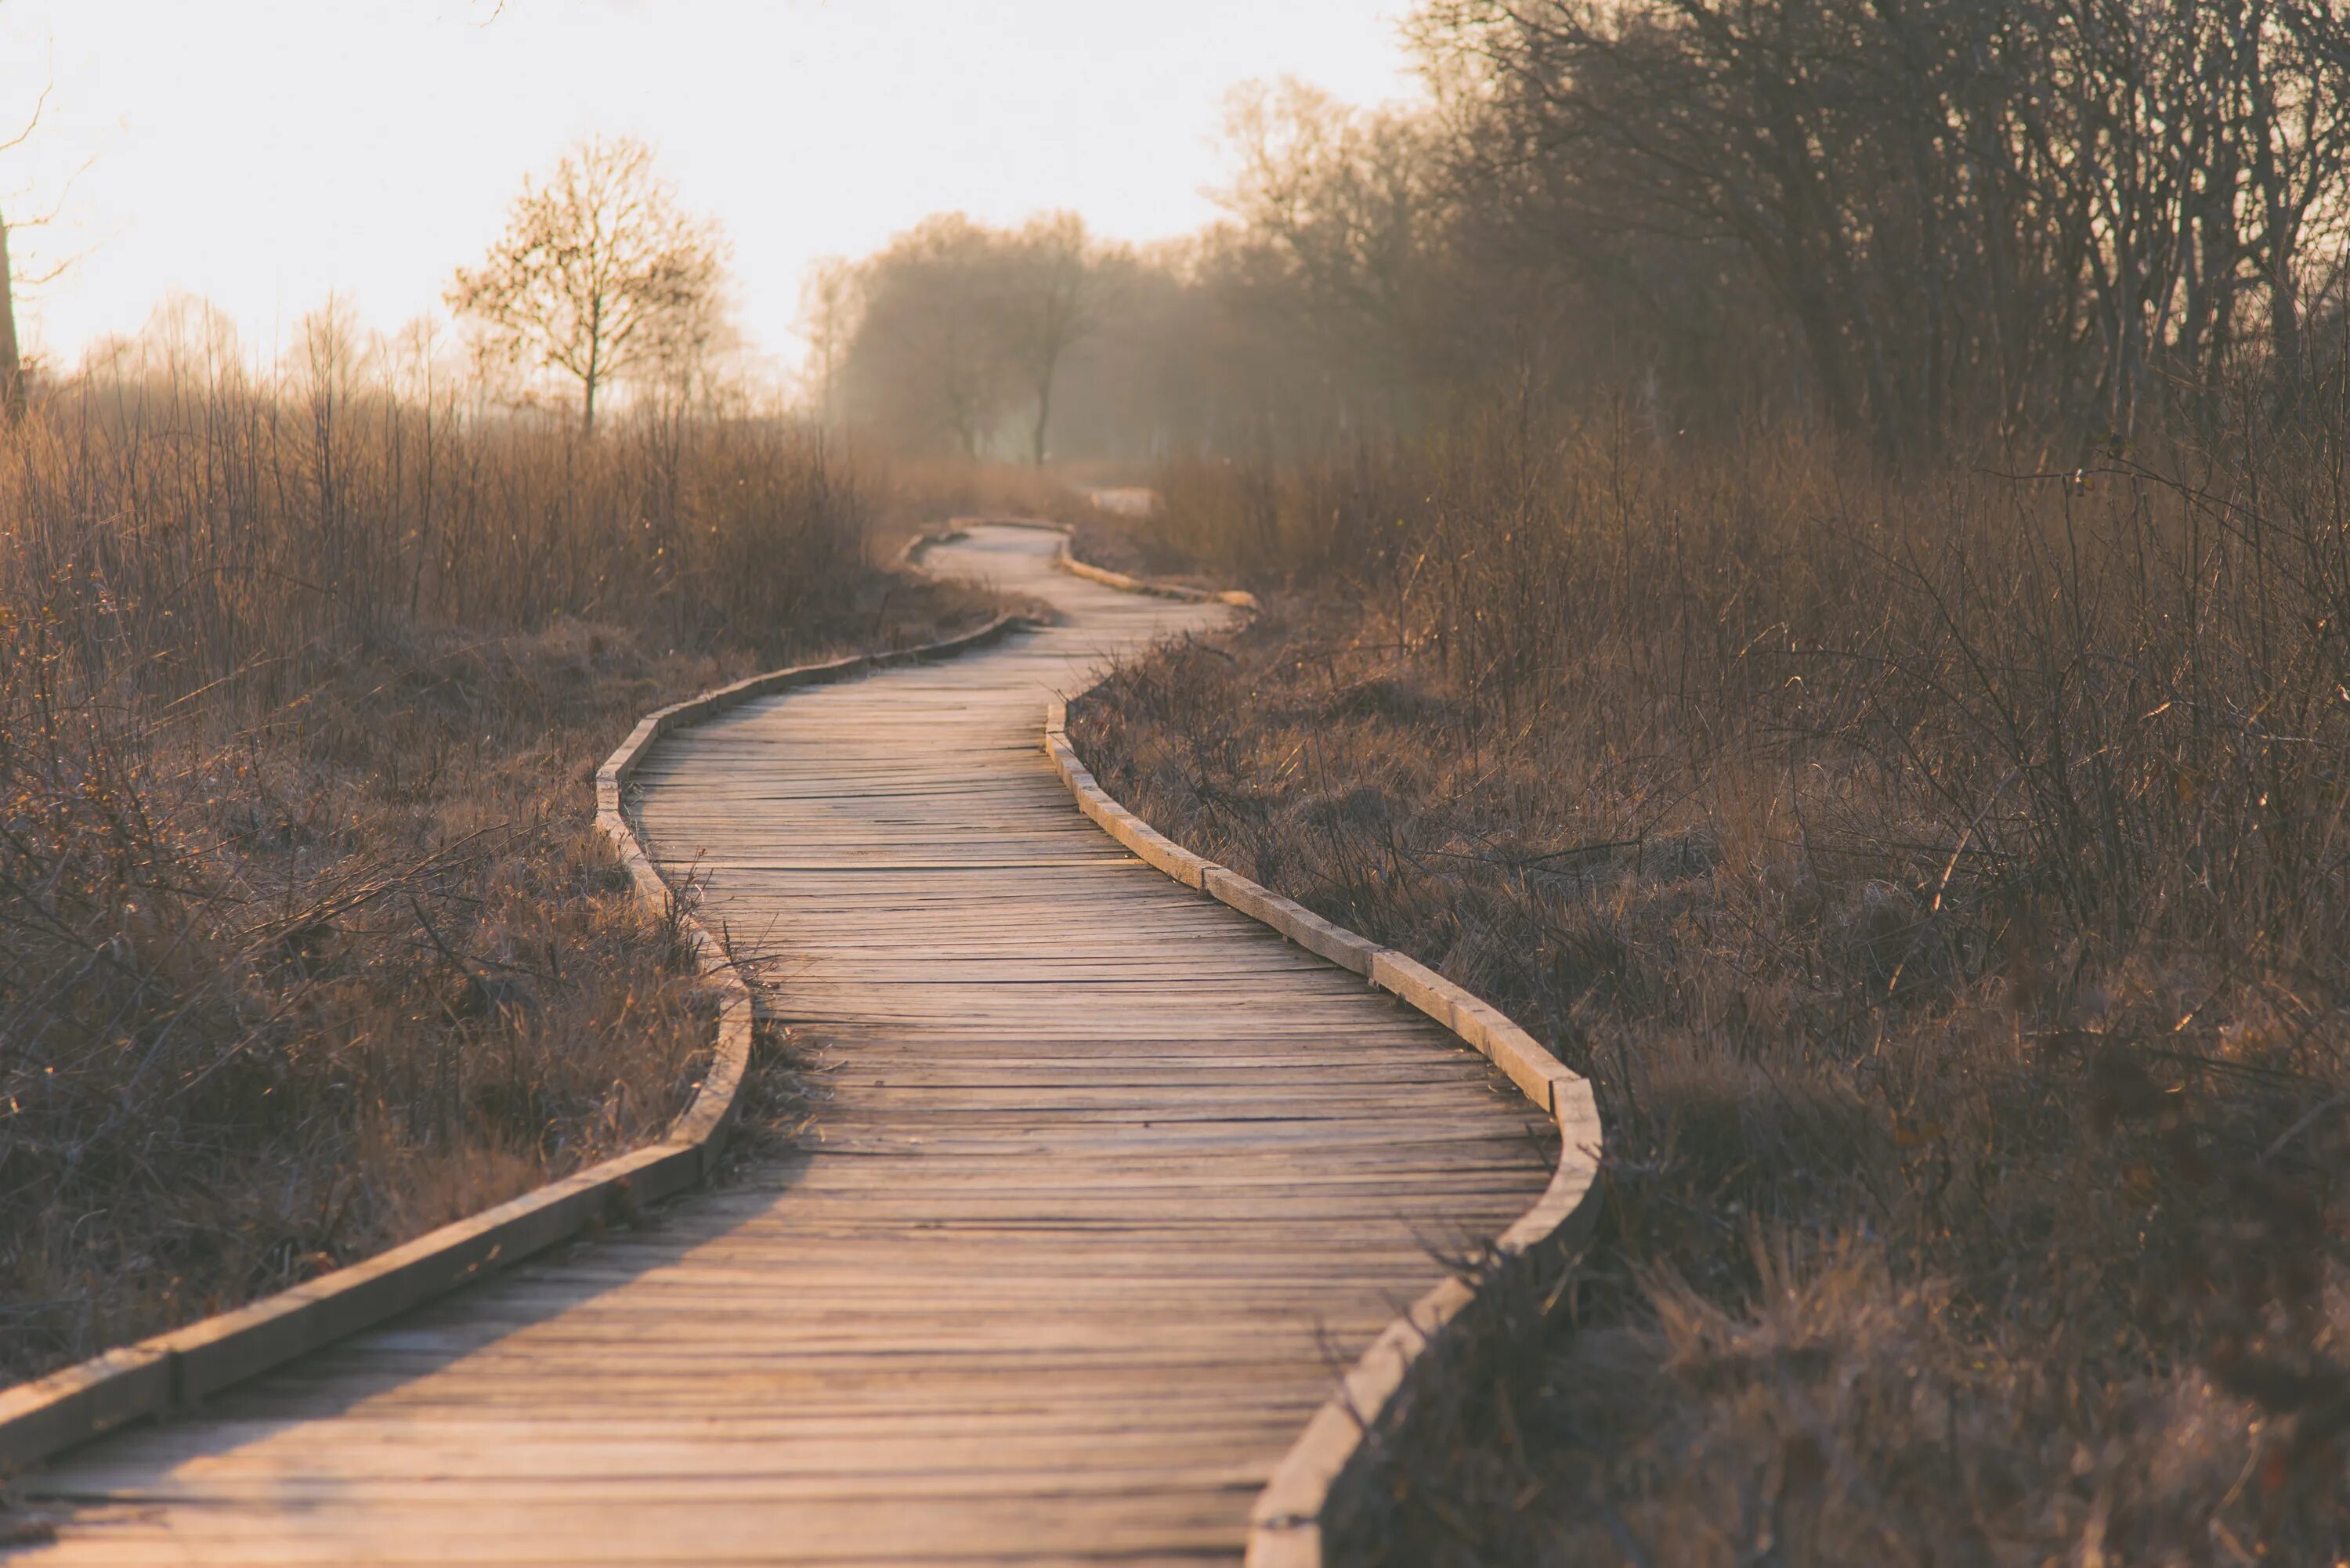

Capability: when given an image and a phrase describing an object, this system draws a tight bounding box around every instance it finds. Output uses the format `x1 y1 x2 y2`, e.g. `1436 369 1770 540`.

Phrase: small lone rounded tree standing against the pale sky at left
446 136 726 432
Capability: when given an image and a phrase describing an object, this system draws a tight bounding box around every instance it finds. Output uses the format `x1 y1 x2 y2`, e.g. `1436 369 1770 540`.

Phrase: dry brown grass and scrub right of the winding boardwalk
1072 385 2350 1568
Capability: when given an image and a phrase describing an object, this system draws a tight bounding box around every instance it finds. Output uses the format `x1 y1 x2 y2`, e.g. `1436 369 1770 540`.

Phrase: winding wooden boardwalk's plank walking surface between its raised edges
12 529 1556 1566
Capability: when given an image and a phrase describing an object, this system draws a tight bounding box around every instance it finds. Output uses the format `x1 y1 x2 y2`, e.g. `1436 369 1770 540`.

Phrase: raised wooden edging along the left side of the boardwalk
0 616 1022 1472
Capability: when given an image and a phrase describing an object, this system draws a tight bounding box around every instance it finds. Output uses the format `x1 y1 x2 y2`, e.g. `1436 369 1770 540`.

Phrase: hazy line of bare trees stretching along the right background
811 0 2350 458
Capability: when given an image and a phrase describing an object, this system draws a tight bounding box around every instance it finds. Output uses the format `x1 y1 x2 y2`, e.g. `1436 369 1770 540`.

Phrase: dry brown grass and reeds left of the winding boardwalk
0 343 985 1378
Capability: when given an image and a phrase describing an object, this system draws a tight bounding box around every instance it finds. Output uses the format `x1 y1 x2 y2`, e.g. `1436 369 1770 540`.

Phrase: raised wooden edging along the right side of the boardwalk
989 519 1605 1568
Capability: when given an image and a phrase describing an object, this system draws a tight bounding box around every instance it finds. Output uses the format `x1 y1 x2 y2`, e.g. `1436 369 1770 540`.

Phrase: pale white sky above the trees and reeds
0 0 1415 376
